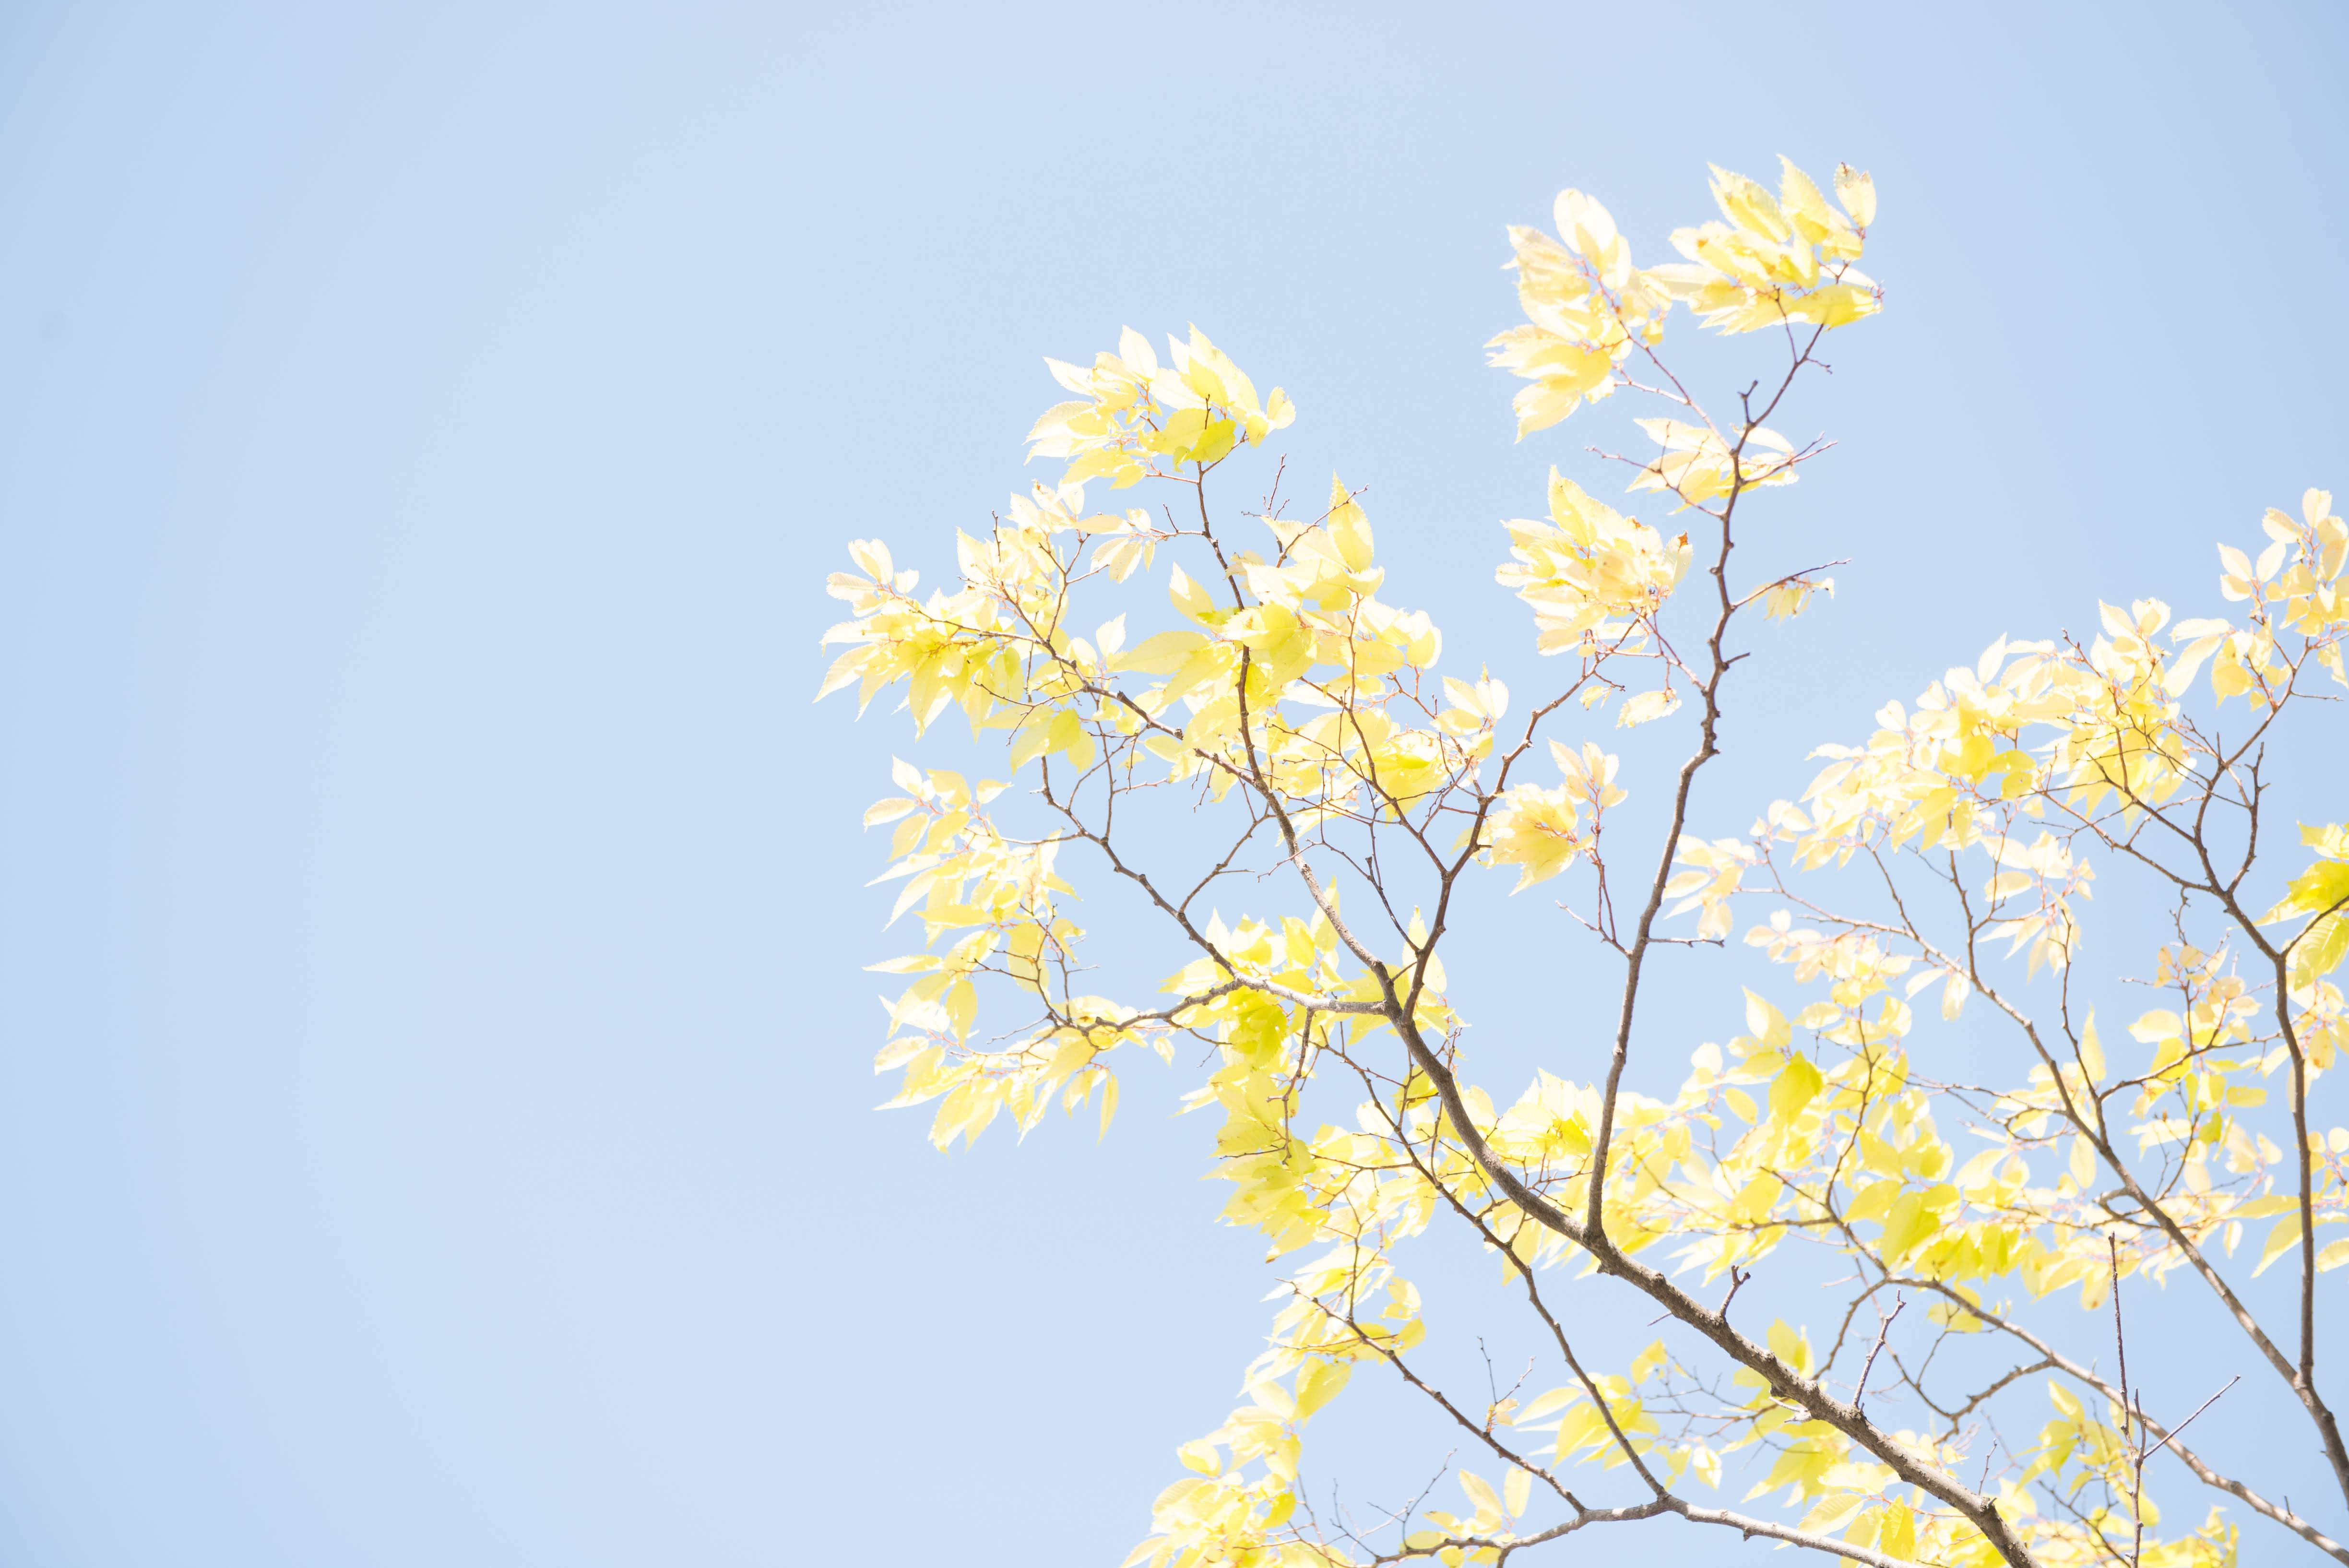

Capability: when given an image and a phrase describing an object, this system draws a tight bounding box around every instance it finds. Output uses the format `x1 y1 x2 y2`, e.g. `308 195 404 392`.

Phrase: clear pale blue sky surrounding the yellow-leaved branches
0 0 2349 1568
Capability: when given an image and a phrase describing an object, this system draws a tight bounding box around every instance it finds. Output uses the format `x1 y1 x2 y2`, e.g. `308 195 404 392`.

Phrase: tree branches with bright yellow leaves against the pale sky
822 165 2349 1568
